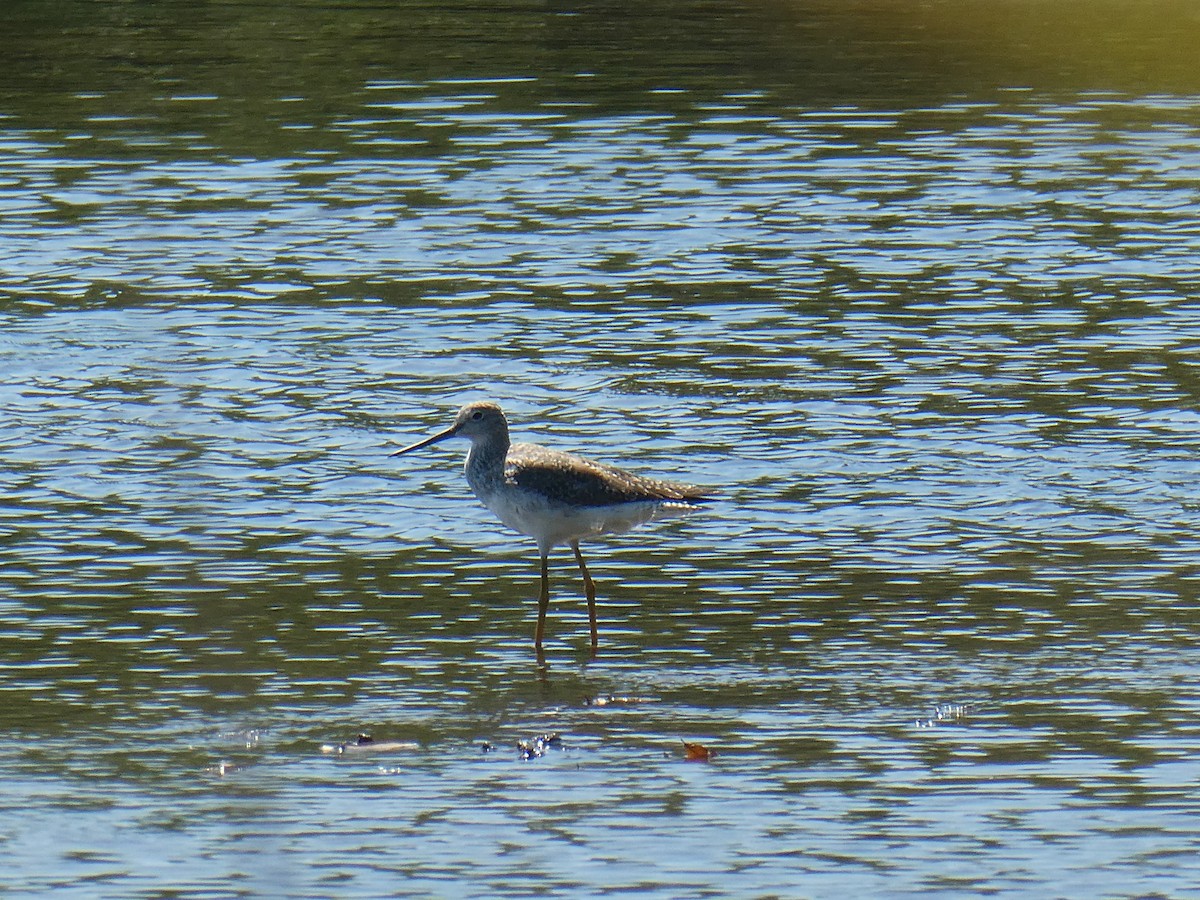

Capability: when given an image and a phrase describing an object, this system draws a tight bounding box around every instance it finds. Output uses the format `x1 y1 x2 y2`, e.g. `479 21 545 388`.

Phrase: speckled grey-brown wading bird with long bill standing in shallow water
391 401 714 661
